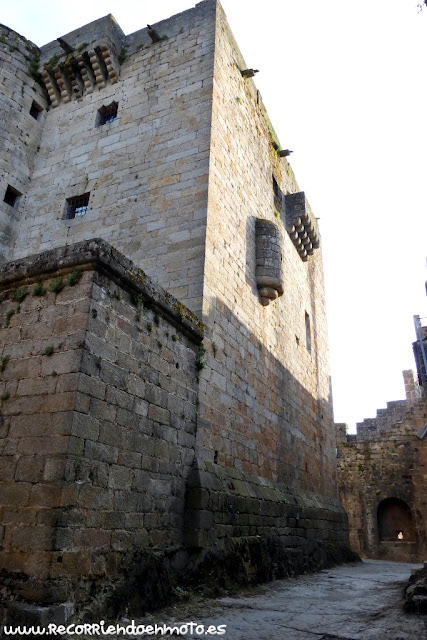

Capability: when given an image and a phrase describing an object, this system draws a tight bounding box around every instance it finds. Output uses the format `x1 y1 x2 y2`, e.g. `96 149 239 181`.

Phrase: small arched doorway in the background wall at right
377 498 415 542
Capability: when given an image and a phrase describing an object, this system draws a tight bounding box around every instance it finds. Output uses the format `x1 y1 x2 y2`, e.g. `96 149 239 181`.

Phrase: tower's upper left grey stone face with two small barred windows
13 2 214 309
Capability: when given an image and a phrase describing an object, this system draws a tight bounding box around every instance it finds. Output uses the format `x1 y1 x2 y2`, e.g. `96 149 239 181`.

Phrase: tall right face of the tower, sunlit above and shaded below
198 6 336 495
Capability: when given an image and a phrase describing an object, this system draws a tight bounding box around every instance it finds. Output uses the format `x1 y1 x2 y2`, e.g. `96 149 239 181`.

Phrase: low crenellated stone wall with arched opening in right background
338 371 427 562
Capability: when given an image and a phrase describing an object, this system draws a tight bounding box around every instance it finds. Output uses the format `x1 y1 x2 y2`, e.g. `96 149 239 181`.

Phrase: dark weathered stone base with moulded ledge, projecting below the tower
0 240 347 611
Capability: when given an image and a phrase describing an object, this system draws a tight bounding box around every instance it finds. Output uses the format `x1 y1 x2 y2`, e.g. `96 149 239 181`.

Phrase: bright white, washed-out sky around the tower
4 0 427 425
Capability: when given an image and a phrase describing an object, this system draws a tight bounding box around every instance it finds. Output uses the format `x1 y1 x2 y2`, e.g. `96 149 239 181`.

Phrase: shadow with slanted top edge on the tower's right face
198 297 337 497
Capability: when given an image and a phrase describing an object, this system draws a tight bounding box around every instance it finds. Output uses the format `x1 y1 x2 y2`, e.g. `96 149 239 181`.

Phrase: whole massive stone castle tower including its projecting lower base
0 0 348 620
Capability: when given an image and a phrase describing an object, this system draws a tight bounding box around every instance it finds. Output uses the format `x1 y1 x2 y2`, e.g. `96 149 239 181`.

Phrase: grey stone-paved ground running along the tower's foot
114 560 427 640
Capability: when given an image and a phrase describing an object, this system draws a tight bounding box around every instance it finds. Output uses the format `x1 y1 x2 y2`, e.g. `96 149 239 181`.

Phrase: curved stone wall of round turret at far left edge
0 25 47 261
